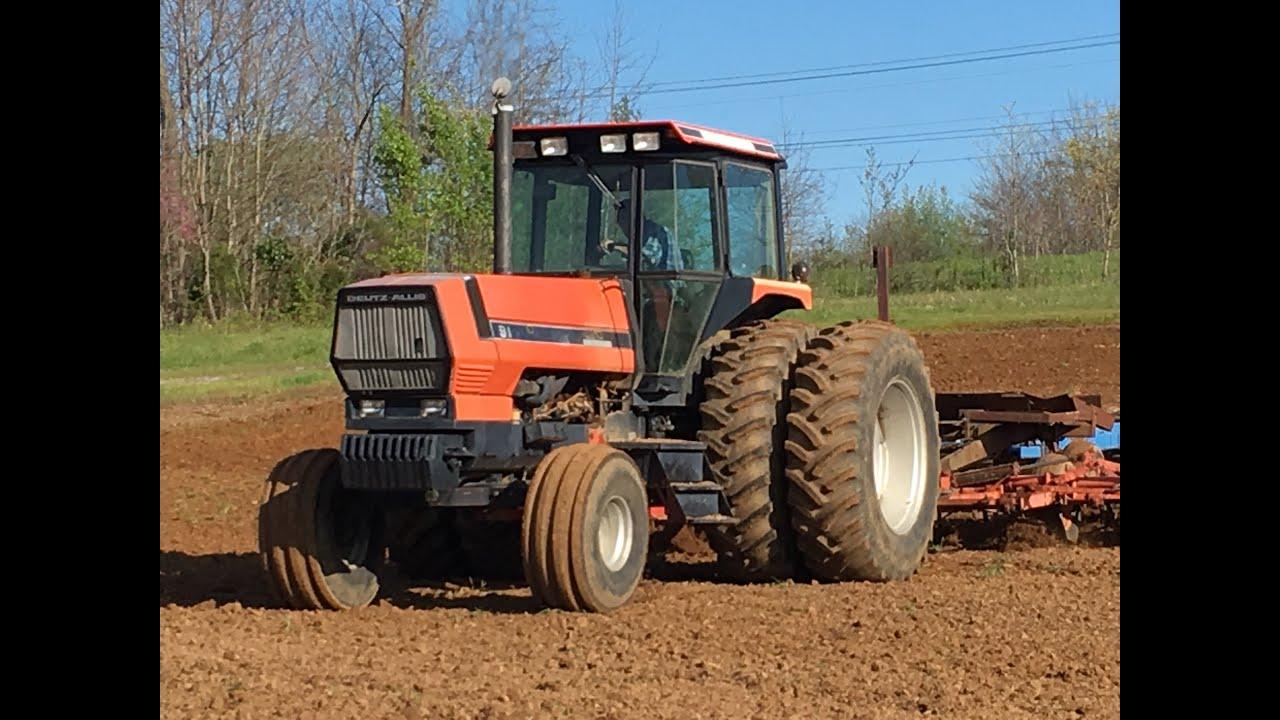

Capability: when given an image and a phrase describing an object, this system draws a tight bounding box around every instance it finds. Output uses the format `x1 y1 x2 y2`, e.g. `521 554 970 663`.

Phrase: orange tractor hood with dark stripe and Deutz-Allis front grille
332 273 635 421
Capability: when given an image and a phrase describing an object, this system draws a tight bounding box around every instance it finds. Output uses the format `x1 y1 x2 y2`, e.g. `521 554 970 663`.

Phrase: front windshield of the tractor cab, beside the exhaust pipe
511 164 632 273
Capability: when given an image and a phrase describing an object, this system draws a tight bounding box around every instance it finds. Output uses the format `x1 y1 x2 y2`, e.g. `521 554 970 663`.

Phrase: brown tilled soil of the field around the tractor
160 327 1120 719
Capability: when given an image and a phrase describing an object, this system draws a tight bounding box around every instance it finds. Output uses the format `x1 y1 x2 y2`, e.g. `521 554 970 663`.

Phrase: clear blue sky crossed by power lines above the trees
542 0 1120 224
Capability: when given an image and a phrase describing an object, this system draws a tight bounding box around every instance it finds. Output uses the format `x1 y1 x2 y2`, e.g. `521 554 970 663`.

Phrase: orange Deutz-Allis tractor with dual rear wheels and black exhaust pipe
260 81 940 612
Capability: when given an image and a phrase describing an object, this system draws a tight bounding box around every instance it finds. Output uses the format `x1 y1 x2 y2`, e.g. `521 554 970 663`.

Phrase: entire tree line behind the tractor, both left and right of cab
160 0 1120 327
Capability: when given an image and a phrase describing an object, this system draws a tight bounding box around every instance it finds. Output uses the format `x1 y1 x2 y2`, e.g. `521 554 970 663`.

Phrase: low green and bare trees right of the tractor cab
791 102 1120 287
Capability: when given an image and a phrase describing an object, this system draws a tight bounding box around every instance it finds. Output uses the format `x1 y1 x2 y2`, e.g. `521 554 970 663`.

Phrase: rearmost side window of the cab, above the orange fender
724 163 778 278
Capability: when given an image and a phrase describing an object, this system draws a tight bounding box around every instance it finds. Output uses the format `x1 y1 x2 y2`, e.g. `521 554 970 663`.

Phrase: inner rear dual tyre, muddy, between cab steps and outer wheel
698 320 814 580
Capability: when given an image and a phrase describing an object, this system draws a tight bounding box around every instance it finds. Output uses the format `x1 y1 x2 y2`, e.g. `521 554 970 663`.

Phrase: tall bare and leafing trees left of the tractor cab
160 0 653 327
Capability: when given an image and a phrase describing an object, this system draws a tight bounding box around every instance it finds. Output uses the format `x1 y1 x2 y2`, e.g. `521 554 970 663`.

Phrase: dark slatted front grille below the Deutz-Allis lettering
333 291 448 392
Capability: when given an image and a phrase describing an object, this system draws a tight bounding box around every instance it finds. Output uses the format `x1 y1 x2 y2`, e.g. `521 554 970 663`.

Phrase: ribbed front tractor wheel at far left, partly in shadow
259 448 384 610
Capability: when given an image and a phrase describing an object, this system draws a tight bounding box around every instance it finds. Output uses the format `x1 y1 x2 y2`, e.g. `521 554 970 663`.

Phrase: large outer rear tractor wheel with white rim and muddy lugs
786 322 940 582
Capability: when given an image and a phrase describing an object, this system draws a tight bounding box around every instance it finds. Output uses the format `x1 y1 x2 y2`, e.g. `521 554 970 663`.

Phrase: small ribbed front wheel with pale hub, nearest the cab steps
521 443 649 612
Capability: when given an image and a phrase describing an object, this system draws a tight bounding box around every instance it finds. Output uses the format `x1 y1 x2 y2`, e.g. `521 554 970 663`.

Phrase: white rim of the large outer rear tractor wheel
872 378 928 536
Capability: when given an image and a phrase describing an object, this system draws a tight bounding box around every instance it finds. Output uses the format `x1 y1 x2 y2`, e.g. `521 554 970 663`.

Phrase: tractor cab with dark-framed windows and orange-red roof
508 120 809 405
